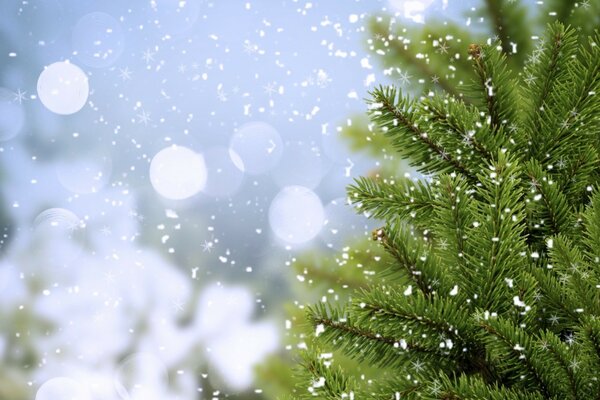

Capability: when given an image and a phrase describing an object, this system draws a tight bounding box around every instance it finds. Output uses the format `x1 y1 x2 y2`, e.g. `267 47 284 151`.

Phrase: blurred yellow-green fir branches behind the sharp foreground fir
259 0 600 399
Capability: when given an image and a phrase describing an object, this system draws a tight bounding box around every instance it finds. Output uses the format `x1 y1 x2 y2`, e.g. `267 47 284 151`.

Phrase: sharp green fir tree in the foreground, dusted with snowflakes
300 23 600 399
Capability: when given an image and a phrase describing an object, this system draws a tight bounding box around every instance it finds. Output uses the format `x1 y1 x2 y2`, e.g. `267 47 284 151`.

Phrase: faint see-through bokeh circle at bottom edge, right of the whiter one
114 353 169 400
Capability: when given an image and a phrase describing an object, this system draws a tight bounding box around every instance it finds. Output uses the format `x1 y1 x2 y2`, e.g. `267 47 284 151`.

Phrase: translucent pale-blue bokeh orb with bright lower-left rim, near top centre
229 122 283 175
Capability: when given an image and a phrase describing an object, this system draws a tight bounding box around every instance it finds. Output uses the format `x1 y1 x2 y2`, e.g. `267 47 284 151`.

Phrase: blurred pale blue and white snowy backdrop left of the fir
0 0 468 400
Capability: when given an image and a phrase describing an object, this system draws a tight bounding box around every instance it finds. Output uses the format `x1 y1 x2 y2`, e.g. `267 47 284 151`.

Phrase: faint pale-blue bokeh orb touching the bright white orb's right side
202 147 244 197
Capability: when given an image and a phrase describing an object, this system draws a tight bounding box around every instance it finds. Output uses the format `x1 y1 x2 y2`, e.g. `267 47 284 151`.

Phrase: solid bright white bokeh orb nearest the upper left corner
37 61 90 115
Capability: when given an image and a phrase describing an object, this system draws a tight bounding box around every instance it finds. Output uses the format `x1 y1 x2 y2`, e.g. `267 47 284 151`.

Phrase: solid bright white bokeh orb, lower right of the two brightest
150 145 207 200
